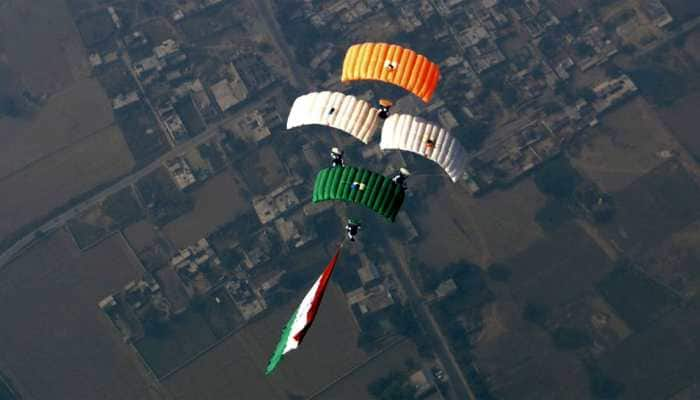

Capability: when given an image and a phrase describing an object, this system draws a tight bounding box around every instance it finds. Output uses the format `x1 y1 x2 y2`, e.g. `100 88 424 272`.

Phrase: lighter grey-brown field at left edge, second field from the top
0 79 113 179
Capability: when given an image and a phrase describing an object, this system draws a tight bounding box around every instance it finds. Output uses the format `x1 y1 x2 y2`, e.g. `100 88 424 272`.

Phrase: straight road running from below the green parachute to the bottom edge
389 240 476 400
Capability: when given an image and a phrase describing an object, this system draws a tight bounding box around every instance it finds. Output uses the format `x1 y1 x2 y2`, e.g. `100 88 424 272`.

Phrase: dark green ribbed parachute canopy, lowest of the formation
313 167 405 222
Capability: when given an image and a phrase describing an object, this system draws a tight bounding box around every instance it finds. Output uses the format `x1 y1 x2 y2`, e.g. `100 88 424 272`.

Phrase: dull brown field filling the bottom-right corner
601 297 700 400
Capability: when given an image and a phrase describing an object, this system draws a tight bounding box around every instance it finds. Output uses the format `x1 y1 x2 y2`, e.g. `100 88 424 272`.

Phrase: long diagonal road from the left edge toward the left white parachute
0 89 284 267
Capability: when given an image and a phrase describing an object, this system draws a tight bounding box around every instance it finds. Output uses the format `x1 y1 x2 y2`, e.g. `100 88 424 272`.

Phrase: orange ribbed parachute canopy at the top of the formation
341 43 440 103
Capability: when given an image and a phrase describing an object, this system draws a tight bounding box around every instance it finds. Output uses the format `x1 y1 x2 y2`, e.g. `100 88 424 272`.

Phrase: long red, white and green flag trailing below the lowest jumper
265 246 340 375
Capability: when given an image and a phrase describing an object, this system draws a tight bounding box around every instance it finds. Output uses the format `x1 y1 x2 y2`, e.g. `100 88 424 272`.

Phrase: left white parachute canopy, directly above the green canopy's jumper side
287 91 379 143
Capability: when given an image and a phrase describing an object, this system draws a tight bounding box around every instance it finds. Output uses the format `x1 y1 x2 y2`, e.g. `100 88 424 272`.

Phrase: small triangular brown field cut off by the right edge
659 93 700 160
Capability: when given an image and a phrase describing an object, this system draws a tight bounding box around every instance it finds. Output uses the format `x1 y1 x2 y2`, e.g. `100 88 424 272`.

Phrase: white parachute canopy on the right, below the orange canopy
379 114 467 182
